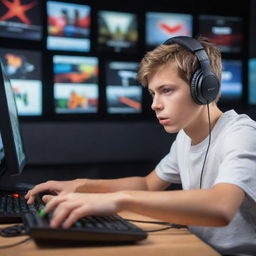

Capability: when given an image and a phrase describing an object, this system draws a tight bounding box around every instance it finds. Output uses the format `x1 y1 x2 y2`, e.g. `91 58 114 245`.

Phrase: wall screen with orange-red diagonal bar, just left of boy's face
106 61 142 114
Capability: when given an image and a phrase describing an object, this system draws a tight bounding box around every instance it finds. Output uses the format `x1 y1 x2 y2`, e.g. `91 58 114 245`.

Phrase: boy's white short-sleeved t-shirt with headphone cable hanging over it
156 110 256 255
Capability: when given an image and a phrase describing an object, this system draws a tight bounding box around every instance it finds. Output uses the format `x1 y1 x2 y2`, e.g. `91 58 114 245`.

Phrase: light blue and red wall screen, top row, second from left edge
47 1 91 52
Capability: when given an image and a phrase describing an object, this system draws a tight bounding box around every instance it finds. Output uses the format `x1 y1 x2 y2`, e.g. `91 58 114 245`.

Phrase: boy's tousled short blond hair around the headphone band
138 37 222 102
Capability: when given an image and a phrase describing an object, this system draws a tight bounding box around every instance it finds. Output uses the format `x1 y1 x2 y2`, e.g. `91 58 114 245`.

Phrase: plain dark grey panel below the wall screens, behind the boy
22 121 173 164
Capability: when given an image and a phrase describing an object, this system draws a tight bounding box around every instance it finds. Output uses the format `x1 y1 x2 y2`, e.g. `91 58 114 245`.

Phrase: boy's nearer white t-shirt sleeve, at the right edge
215 125 256 202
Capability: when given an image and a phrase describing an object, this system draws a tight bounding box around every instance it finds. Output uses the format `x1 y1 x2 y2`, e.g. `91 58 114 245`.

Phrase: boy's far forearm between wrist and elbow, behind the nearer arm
76 177 148 193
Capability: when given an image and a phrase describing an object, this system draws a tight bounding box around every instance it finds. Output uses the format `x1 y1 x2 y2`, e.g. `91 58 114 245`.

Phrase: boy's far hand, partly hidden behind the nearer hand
25 179 82 204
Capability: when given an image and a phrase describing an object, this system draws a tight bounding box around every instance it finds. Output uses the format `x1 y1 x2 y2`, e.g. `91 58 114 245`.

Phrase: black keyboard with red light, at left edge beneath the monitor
0 191 44 223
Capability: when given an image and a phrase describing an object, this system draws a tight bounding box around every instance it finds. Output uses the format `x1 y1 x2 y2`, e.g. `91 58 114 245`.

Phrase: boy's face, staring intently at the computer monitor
148 63 203 133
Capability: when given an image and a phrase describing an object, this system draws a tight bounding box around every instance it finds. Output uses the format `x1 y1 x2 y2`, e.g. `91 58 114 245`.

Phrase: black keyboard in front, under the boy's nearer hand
23 212 147 245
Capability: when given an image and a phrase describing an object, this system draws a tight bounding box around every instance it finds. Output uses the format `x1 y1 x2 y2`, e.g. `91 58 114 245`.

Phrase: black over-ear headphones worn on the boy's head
163 36 220 105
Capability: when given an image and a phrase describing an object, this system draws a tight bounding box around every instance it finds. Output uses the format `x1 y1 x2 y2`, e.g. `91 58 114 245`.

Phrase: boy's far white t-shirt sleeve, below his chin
155 140 181 183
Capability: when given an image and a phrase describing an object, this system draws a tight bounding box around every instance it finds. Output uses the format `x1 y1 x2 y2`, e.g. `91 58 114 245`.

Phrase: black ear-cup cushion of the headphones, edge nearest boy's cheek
190 69 207 105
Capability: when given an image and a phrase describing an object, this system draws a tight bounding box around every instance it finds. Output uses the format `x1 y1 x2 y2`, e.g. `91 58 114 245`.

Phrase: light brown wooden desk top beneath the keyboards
0 213 220 256
